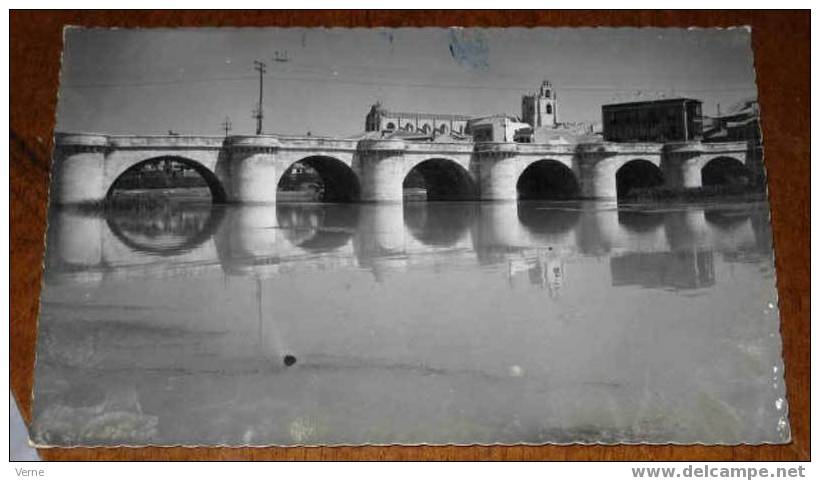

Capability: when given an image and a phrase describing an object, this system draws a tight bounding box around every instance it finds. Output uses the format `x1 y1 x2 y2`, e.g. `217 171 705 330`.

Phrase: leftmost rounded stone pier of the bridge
53 134 108 204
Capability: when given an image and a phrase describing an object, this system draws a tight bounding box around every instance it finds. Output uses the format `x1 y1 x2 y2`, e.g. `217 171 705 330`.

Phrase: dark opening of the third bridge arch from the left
402 157 478 201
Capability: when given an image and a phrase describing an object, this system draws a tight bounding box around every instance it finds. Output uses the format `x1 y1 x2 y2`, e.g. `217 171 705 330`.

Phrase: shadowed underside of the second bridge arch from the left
276 155 361 202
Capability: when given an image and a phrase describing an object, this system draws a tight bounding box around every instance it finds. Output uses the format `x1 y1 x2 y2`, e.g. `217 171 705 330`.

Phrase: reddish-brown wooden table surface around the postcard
10 11 810 460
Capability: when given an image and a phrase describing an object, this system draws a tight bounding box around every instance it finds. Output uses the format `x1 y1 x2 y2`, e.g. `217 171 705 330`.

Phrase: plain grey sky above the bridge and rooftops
57 28 756 136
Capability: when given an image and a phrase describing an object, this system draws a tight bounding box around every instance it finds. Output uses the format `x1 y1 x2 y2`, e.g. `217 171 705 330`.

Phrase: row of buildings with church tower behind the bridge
365 80 760 144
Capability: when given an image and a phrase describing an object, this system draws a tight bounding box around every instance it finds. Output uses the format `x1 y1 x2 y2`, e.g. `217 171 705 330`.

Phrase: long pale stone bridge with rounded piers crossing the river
52 133 762 204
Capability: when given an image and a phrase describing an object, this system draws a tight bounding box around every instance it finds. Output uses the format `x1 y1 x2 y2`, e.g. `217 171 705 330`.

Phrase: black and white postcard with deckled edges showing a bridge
31 28 790 446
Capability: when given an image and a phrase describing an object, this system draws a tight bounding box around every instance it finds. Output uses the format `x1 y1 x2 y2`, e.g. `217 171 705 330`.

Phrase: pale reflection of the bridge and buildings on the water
46 202 771 289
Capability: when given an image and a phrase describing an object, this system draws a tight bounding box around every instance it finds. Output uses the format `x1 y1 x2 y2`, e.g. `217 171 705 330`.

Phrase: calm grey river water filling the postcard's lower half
32 197 790 446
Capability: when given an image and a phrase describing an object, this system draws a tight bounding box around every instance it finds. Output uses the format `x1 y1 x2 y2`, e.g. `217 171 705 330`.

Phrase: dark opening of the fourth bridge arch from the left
515 159 581 200
